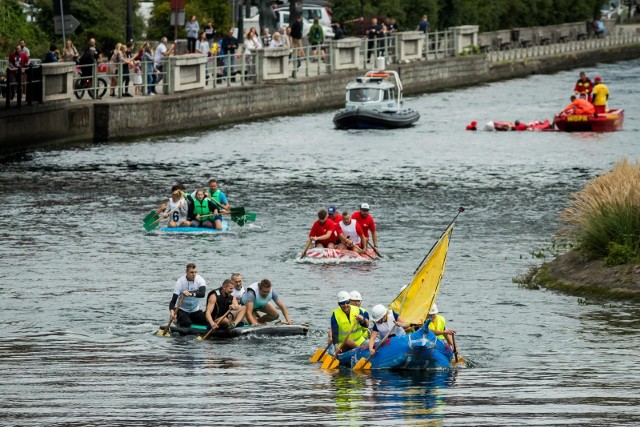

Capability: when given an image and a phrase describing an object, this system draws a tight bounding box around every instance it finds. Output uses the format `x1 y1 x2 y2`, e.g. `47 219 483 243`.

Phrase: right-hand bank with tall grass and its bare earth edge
513 158 640 300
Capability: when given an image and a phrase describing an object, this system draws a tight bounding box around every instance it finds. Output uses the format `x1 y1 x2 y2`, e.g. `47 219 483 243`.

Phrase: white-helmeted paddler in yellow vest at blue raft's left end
331 291 369 355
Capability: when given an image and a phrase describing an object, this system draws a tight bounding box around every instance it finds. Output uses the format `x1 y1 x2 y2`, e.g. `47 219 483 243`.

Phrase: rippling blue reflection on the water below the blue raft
371 369 457 425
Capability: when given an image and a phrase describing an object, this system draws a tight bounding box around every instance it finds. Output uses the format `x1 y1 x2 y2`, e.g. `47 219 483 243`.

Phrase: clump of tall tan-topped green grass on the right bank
560 158 640 264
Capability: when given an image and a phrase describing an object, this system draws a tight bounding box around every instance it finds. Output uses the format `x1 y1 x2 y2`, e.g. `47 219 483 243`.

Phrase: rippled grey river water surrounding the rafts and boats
0 61 640 426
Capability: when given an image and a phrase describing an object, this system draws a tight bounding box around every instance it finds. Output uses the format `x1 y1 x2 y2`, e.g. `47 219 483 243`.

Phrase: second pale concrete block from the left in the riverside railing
163 53 207 94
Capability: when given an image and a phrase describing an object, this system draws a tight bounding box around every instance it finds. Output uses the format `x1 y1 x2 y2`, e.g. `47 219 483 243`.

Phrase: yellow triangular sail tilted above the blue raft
389 222 453 325
